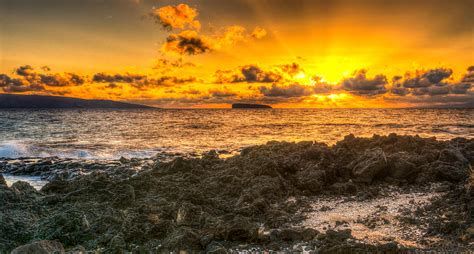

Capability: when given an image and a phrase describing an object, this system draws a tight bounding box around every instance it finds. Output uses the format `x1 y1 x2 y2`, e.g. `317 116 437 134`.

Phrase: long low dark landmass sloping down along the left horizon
0 94 151 109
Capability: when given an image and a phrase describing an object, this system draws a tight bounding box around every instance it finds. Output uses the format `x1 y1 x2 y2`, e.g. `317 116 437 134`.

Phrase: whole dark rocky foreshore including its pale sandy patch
0 134 474 253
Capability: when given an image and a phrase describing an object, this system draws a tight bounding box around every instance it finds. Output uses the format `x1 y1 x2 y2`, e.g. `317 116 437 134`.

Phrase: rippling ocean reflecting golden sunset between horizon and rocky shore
0 109 474 159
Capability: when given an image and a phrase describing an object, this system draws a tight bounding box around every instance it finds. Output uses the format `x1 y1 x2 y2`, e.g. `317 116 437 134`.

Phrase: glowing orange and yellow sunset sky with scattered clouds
0 0 474 108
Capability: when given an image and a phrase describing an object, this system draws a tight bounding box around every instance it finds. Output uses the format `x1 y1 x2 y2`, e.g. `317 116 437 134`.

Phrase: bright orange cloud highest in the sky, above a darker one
150 4 201 30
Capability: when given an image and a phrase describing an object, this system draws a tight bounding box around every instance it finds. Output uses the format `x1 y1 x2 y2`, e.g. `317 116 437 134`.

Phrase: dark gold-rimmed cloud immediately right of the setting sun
341 69 388 96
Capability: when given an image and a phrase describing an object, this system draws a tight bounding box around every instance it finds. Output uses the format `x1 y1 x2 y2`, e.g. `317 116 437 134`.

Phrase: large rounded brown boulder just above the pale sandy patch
352 148 388 183
